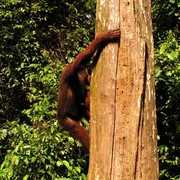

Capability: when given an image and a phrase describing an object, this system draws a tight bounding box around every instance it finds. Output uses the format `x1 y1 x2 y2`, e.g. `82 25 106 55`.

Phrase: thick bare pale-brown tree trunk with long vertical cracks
88 0 158 180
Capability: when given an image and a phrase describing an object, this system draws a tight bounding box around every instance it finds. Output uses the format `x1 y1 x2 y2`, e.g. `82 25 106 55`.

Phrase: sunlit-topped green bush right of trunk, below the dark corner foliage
155 31 180 179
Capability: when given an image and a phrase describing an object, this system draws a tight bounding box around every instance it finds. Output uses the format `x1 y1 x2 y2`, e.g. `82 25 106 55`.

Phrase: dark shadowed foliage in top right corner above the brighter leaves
152 0 180 48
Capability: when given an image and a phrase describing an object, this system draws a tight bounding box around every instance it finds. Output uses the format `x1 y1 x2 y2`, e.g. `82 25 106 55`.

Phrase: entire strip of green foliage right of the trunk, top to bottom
152 0 180 180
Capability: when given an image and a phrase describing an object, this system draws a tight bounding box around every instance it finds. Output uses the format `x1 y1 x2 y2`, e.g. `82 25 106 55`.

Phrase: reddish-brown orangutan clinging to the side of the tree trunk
57 29 120 152
